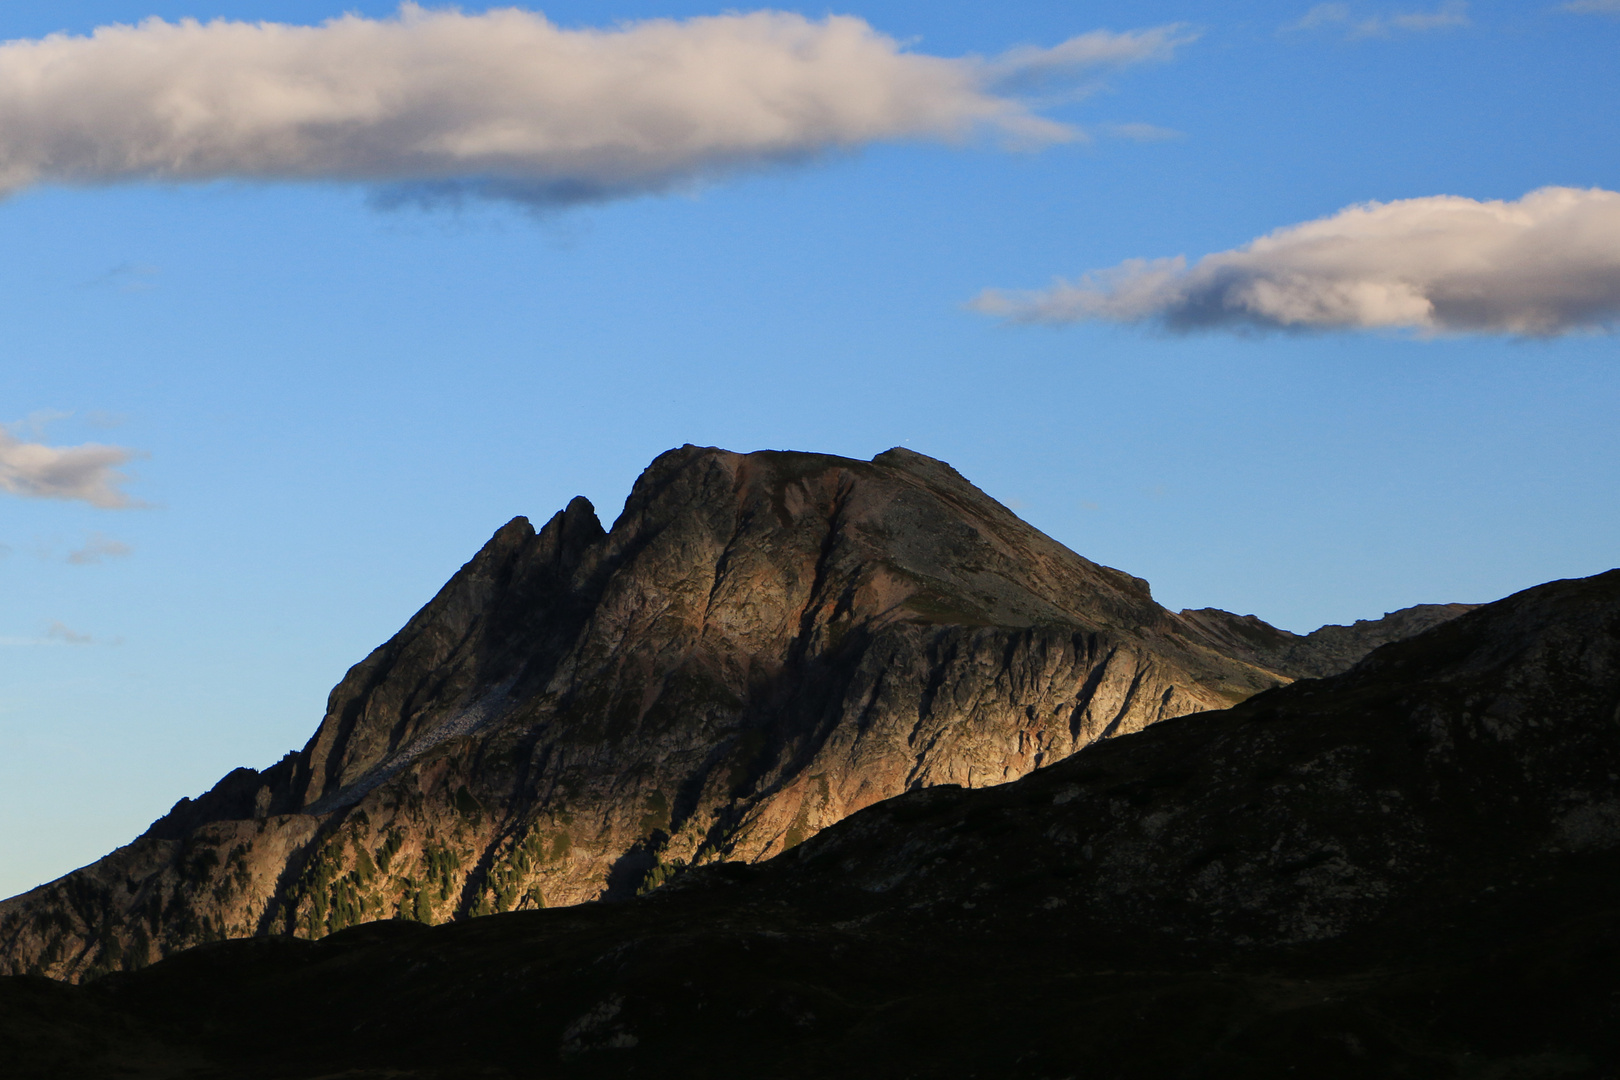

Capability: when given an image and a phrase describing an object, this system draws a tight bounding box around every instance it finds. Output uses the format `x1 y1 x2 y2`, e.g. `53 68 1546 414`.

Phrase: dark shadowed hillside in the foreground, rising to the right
0 572 1620 1080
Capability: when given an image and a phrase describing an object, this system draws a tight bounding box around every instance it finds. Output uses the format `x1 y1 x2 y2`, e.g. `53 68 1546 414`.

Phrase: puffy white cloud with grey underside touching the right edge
972 188 1620 337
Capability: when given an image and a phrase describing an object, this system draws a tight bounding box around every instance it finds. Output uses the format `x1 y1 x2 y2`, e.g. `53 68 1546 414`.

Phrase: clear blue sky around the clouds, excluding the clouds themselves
0 0 1620 894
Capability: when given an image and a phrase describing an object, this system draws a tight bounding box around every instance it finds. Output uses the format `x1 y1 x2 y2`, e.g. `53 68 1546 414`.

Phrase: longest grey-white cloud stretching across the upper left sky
0 5 1191 204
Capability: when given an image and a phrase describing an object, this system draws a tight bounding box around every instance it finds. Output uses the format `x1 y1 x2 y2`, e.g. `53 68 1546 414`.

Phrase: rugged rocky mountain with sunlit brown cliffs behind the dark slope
0 447 1470 980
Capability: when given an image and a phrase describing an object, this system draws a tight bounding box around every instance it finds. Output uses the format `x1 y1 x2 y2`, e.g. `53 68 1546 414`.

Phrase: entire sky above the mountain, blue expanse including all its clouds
0 0 1620 895
